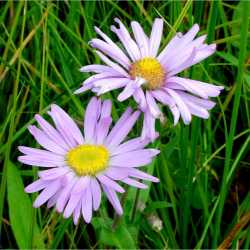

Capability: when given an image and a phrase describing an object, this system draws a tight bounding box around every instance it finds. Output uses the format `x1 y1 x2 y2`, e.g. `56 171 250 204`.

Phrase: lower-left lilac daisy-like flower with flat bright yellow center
18 97 159 224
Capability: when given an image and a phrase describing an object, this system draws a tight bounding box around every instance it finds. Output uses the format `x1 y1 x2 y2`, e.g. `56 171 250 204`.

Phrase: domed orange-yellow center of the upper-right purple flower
130 57 165 89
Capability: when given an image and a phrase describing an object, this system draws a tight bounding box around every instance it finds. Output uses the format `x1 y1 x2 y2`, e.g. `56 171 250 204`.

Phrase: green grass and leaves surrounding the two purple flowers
0 0 250 249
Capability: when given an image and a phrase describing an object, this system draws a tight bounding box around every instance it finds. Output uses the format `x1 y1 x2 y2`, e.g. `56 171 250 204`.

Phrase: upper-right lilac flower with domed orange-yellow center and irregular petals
75 18 223 139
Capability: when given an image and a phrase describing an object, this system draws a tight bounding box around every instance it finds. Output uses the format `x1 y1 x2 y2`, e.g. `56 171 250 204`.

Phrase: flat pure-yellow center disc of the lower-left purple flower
66 144 109 175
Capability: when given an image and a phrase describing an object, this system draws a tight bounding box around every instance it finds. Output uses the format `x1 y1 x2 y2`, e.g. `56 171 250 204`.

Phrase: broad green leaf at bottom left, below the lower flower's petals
7 162 44 249
